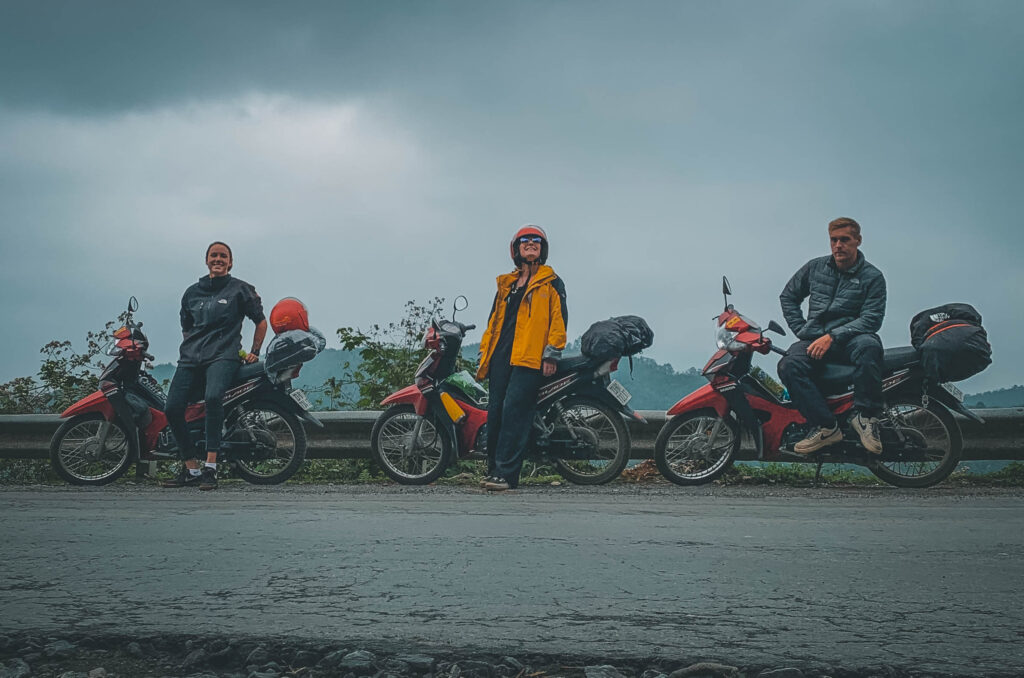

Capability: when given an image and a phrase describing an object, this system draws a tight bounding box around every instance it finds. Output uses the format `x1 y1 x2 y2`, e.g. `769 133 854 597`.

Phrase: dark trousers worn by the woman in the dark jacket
164 361 241 459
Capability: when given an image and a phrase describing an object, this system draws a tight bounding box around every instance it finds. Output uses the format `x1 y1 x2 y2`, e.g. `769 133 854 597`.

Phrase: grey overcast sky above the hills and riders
0 0 1024 395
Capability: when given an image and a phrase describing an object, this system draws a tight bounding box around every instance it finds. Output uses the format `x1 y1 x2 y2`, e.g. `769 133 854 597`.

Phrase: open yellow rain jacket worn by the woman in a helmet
476 265 568 379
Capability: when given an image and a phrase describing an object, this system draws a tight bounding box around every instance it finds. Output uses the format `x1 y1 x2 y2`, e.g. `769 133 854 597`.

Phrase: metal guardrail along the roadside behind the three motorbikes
0 408 1024 461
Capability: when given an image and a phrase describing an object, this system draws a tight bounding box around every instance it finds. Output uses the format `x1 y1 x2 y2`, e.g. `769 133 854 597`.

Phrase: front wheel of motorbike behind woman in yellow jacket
370 405 455 485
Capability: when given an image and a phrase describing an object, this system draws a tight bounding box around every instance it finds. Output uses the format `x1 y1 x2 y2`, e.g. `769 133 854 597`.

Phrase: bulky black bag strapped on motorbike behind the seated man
910 303 992 383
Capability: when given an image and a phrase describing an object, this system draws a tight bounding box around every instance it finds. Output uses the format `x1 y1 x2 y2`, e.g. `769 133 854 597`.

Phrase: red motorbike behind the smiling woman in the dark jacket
50 297 324 485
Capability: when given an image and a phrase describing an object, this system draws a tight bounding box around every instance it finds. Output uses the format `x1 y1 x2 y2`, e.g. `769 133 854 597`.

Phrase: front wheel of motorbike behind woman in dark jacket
50 412 138 485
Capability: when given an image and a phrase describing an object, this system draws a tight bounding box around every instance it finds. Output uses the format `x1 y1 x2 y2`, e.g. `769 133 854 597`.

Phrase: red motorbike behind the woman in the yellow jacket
371 296 644 484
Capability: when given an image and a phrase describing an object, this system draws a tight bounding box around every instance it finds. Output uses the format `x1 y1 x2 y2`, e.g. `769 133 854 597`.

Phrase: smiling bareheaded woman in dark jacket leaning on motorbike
162 242 266 490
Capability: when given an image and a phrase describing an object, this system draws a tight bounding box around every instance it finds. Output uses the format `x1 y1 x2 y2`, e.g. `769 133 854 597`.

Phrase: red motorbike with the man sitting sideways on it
654 278 981 488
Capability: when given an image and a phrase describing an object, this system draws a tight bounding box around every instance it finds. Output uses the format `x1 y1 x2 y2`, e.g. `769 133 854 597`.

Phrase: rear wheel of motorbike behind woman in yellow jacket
552 397 631 485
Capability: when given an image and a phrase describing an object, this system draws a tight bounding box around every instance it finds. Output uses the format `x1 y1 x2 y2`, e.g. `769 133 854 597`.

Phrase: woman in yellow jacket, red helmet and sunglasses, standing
476 225 568 491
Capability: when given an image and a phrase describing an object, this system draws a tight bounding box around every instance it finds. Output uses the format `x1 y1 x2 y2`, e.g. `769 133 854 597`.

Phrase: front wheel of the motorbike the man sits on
654 410 740 485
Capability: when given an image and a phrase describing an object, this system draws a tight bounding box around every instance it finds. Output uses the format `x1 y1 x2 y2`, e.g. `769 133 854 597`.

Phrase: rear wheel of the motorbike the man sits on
868 396 964 488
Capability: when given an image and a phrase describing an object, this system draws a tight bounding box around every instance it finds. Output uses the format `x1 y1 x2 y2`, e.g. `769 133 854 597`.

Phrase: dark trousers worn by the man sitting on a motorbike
778 334 882 427
